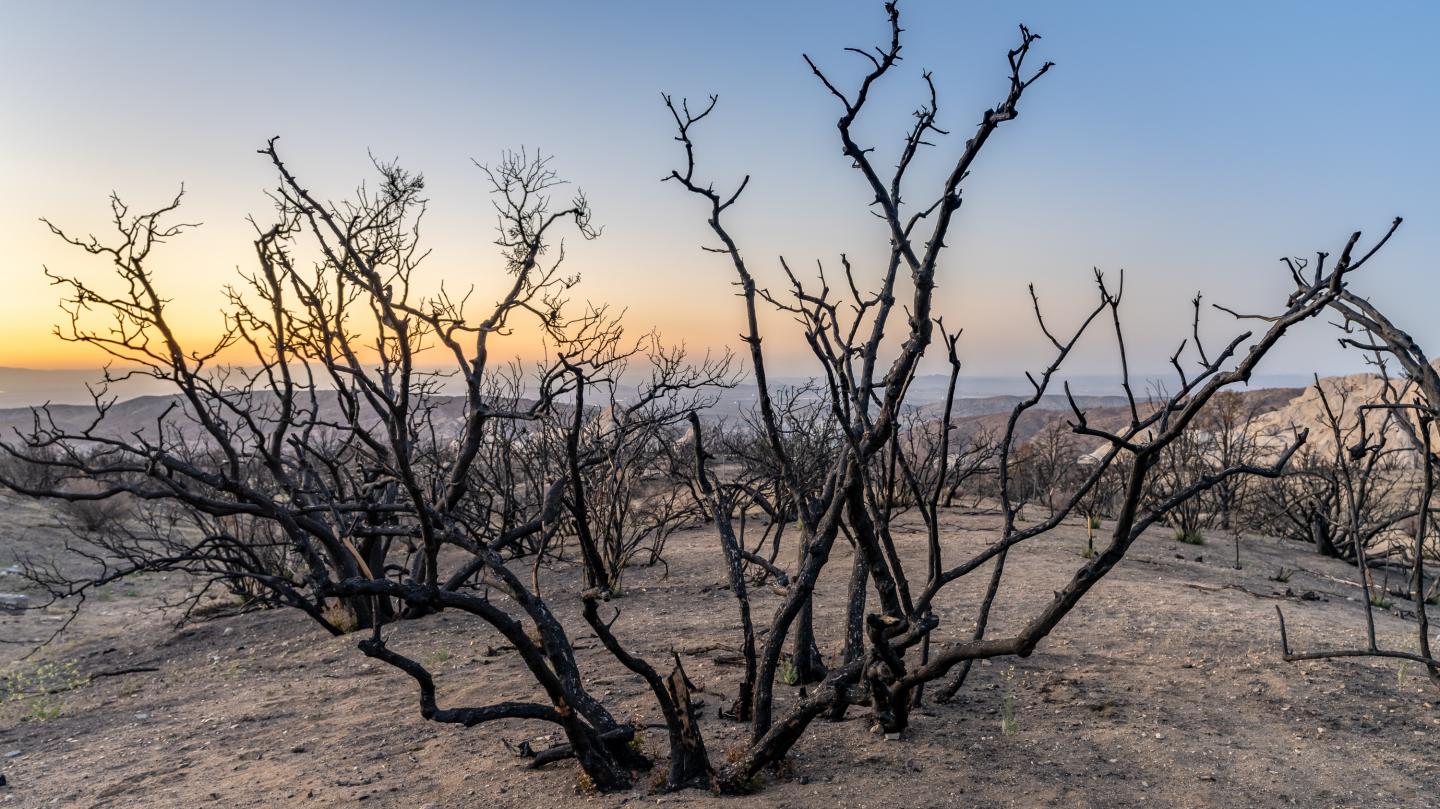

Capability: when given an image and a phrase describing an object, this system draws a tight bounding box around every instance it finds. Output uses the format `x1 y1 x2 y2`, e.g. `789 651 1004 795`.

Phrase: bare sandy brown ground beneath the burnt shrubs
0 489 1440 809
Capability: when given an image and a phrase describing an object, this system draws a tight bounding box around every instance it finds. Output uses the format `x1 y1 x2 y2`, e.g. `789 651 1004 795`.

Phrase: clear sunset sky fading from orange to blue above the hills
0 0 1440 373
